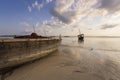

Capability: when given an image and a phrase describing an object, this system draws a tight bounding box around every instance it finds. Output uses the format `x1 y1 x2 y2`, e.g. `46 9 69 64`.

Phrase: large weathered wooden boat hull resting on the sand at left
0 33 61 71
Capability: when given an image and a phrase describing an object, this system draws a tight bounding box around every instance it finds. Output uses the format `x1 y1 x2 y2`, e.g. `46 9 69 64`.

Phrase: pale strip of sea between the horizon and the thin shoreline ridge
62 37 120 51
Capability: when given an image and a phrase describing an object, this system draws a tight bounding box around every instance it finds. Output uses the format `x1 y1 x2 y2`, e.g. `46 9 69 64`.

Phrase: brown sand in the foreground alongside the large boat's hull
6 49 103 80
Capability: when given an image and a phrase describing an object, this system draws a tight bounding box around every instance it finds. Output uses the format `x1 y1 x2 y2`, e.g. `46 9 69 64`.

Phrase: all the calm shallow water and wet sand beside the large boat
6 37 120 80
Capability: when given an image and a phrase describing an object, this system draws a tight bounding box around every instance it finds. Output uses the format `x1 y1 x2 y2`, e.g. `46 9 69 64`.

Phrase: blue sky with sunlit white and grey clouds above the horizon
0 0 120 36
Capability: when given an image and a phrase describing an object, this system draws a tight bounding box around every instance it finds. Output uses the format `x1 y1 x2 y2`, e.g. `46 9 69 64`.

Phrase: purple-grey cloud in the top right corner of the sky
94 0 120 13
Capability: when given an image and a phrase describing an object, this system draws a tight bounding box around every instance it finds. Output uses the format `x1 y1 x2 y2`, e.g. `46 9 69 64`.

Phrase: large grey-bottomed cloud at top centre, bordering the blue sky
50 0 80 24
